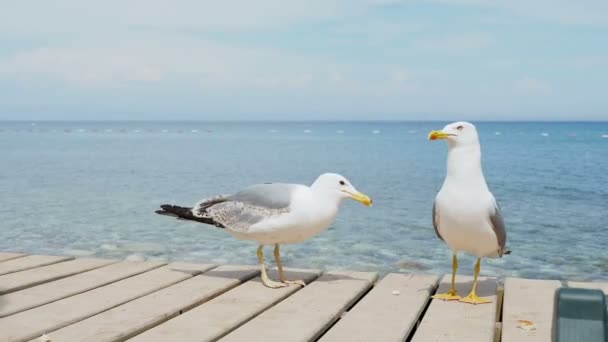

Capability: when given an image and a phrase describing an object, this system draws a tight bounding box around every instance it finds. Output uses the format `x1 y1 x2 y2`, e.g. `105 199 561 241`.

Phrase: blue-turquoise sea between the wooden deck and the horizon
0 122 608 280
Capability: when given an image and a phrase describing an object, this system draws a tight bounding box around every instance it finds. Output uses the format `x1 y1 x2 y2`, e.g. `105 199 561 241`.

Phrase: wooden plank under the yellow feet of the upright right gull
412 276 498 342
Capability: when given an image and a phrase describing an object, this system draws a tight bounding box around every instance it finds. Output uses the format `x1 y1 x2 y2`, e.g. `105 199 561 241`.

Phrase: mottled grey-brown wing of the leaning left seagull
193 183 297 232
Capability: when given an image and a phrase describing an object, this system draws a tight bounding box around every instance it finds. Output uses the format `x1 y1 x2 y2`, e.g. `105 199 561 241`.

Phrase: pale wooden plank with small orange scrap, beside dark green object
502 278 561 342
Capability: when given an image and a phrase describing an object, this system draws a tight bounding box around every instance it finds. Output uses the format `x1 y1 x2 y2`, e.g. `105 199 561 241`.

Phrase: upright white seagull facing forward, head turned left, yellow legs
429 122 509 304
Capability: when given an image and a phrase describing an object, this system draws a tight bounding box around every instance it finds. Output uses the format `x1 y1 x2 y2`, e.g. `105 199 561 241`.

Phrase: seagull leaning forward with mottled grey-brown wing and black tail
156 173 372 288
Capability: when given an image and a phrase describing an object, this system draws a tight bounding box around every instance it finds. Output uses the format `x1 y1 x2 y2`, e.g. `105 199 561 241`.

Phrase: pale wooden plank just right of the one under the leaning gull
222 272 377 342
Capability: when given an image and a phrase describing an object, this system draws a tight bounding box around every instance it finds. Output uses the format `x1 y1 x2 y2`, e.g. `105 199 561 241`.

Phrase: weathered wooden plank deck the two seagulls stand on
0 253 608 342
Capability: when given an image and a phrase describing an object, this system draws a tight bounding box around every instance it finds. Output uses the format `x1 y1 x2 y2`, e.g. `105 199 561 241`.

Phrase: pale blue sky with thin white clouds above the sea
0 0 608 120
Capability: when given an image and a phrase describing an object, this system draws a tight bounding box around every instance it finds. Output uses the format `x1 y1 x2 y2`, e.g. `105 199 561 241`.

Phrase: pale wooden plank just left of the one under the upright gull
320 273 439 342
